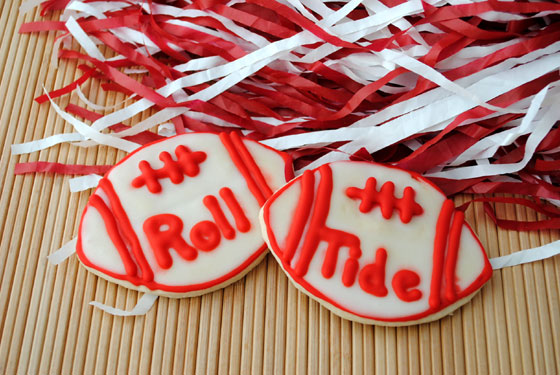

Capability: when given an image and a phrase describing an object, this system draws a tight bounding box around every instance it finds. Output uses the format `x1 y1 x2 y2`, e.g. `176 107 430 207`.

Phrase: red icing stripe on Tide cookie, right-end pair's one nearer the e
429 199 454 309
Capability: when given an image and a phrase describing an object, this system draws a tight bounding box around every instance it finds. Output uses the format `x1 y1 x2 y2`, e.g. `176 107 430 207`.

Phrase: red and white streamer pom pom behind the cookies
13 0 560 229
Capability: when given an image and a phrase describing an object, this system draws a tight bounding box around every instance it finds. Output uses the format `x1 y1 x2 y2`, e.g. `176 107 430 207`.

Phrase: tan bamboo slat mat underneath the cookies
0 1 560 374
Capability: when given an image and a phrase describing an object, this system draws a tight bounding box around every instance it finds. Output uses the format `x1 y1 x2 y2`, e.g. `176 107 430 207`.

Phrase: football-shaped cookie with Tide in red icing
261 161 492 326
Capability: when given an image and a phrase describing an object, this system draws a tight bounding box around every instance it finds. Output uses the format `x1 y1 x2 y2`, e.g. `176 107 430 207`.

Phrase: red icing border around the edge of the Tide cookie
262 161 492 322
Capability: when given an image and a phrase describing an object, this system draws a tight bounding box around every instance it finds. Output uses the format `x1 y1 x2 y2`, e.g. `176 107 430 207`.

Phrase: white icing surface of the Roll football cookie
82 133 286 286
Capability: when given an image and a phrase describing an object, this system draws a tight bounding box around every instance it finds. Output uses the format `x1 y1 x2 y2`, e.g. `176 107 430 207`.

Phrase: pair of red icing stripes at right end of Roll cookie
220 132 272 206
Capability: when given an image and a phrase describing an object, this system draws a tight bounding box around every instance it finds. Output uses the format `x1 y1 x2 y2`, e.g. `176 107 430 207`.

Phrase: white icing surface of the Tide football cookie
269 162 485 319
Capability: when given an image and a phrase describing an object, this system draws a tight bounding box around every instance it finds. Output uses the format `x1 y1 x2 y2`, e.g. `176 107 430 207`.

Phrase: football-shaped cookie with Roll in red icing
77 133 293 297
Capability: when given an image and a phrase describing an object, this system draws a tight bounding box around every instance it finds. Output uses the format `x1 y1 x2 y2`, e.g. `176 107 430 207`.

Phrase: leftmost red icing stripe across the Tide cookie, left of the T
281 170 315 263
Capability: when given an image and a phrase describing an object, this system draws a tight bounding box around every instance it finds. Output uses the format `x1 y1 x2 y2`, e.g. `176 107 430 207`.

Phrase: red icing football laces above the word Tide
346 177 424 224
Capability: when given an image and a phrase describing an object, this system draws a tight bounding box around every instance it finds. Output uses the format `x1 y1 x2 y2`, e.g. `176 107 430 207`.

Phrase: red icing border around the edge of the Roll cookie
76 132 294 293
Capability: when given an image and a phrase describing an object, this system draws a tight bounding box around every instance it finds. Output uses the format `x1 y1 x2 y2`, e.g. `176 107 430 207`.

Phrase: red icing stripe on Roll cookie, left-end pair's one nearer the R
99 178 154 281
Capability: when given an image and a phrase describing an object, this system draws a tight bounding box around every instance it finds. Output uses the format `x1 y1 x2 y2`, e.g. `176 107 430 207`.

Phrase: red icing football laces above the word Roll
132 145 206 194
